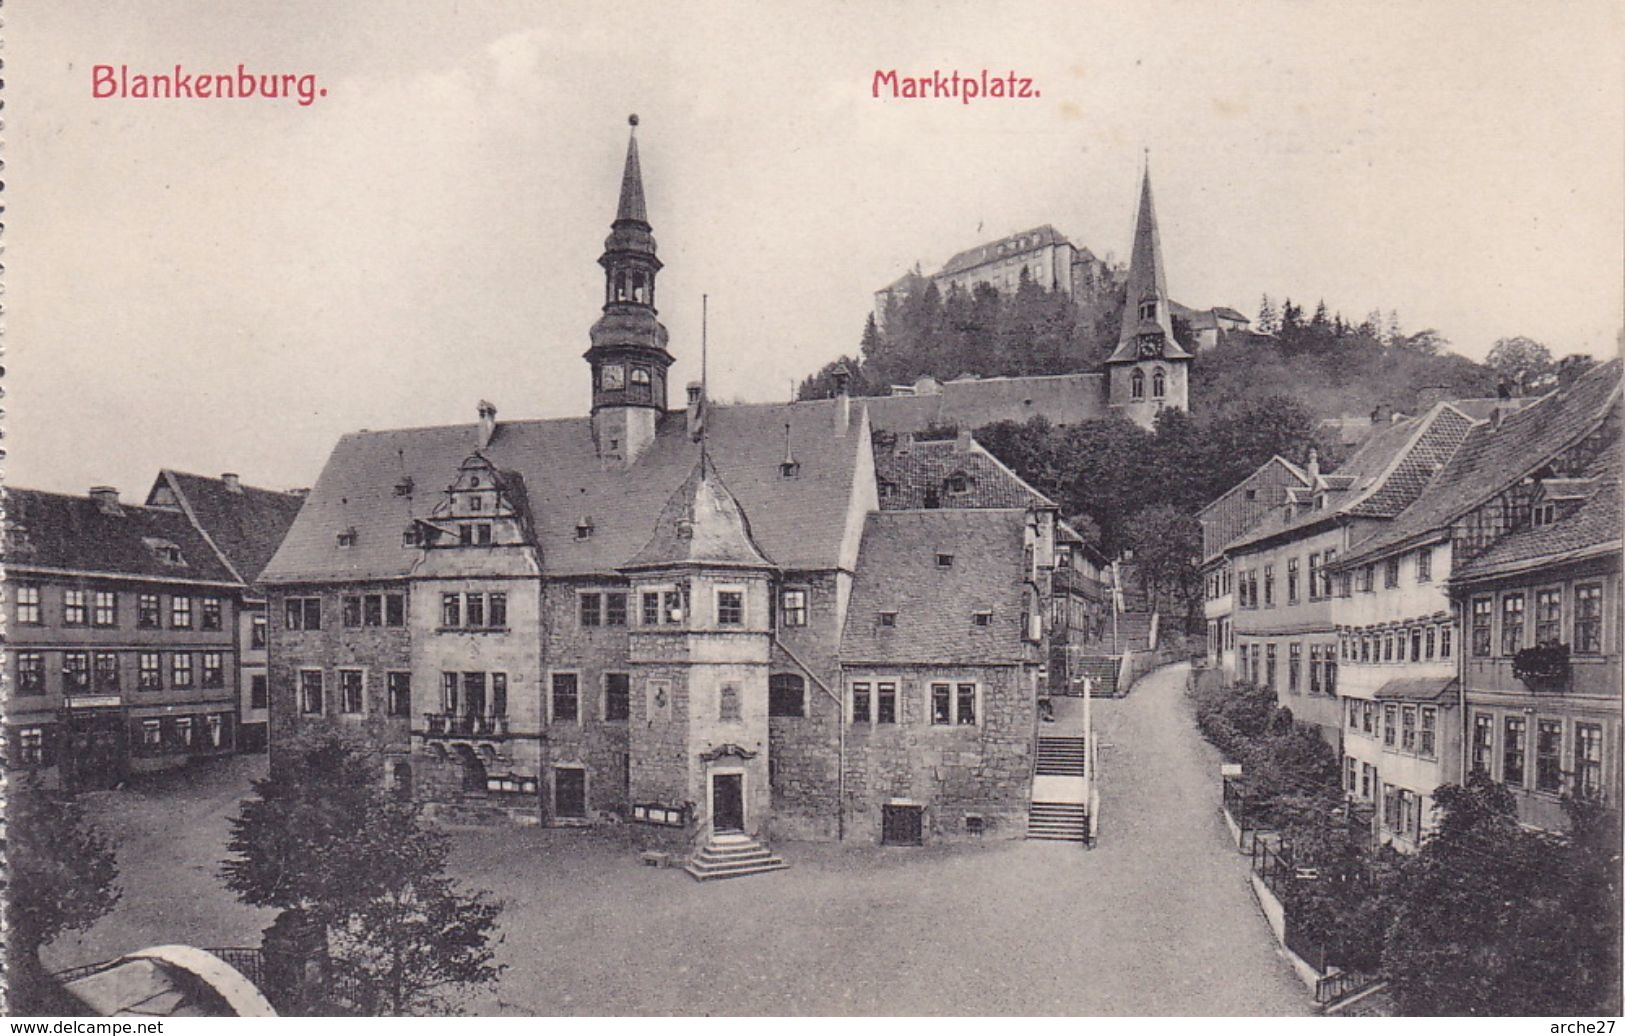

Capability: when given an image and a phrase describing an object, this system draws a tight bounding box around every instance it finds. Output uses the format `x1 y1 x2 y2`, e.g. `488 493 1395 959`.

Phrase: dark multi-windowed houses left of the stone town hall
5 471 304 788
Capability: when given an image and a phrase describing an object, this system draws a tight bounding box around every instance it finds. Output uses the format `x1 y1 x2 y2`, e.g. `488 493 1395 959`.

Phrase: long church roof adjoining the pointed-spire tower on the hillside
853 373 1107 435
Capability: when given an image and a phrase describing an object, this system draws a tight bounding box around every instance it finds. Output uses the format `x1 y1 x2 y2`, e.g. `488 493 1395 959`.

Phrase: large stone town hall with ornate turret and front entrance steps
263 117 1124 857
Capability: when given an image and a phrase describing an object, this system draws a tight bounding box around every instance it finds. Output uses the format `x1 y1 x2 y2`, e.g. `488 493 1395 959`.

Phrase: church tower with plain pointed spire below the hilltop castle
1107 166 1191 429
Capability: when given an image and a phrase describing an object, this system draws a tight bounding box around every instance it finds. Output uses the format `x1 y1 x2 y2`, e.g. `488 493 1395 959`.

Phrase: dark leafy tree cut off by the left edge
5 773 119 1015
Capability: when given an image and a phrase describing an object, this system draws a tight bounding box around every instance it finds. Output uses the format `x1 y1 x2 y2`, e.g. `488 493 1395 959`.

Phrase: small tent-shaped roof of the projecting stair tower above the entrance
626 460 774 568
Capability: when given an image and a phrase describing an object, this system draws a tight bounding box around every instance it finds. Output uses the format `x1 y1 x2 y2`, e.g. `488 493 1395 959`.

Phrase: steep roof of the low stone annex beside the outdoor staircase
840 510 1025 666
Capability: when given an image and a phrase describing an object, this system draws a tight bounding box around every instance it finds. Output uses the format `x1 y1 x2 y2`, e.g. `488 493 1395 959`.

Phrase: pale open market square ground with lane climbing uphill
50 667 1308 1015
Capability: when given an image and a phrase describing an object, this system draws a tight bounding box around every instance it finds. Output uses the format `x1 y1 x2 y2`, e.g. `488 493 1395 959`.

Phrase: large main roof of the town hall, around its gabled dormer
262 399 869 583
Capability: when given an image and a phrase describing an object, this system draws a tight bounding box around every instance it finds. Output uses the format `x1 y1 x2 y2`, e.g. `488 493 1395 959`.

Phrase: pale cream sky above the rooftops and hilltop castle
15 0 1625 500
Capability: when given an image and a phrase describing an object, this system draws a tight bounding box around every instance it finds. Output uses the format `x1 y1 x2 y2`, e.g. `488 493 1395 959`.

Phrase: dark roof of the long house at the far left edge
5 489 239 583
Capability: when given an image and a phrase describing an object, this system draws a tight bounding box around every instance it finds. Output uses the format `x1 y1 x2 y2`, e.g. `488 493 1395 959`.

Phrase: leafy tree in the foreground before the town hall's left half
221 734 501 1015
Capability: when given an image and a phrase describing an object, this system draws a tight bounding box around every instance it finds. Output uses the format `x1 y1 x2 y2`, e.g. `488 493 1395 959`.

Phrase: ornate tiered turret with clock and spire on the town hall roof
585 115 673 466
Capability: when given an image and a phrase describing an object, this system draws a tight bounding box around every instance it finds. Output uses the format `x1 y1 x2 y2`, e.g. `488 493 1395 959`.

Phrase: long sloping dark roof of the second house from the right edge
1339 360 1620 565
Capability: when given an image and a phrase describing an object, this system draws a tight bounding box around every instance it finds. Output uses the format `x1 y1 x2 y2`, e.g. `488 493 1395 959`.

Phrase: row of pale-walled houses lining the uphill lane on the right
1199 360 1622 849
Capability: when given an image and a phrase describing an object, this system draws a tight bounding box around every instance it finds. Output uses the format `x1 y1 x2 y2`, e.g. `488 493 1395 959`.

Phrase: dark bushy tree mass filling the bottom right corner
1383 771 1620 1017
